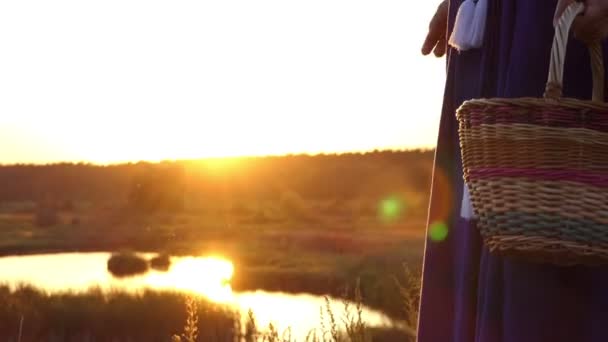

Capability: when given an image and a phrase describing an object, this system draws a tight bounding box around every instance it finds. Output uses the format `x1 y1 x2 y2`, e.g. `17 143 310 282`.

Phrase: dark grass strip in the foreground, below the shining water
0 286 413 342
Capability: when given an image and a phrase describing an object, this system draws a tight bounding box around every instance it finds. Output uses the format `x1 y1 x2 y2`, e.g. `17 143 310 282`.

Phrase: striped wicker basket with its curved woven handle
457 3 608 265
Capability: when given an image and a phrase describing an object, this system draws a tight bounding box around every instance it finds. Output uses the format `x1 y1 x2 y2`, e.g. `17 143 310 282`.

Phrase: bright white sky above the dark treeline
0 0 445 164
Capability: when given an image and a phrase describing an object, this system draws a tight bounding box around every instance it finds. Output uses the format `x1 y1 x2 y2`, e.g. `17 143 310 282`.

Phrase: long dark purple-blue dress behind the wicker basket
418 0 608 342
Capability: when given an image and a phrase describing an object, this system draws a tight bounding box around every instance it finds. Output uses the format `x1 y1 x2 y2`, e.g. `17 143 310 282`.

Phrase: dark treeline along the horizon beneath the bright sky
0 150 433 210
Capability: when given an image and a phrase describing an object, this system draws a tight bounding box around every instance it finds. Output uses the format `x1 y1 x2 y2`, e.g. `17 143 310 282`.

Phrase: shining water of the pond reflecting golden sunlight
0 253 400 336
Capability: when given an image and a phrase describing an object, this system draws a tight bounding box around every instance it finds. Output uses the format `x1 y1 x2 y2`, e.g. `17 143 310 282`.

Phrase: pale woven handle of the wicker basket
544 2 604 102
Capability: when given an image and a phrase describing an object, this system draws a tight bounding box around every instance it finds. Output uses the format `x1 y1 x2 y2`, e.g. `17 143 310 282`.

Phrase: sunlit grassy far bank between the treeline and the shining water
0 204 424 318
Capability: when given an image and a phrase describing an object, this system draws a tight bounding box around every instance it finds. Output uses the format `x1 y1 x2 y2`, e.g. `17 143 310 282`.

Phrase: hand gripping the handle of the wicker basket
553 0 608 42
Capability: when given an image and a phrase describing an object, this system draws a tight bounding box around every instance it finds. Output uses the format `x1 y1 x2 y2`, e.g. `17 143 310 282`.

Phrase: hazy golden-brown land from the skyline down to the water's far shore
0 151 432 340
